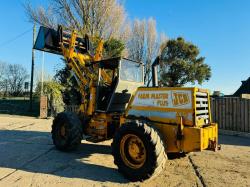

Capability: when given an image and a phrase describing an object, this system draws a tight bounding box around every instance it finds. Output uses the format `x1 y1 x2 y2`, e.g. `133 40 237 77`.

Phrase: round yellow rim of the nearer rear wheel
120 134 146 169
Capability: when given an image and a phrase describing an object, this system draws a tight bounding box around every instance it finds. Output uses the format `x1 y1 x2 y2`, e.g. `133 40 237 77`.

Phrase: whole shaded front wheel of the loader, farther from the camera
51 112 82 151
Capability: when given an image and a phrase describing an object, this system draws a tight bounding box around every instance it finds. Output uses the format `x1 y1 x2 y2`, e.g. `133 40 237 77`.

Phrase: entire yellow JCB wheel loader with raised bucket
34 26 218 181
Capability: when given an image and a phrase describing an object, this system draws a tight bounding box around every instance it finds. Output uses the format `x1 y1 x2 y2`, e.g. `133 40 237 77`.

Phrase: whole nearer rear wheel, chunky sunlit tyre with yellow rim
112 122 167 181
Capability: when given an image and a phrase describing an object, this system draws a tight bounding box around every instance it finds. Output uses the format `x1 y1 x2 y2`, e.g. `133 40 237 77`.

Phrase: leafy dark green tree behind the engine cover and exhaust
160 37 211 87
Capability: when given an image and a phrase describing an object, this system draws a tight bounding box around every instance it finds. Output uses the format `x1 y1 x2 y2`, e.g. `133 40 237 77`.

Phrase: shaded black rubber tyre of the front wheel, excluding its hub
51 112 82 151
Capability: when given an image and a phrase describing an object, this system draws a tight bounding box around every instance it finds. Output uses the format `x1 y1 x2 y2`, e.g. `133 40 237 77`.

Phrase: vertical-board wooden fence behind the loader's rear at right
211 97 250 132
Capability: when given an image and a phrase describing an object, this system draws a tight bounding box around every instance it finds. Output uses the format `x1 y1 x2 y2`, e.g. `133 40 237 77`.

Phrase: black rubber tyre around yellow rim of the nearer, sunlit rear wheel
111 121 167 181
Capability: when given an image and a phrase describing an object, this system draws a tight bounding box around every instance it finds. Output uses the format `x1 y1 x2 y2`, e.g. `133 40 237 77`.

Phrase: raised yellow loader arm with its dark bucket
34 26 111 115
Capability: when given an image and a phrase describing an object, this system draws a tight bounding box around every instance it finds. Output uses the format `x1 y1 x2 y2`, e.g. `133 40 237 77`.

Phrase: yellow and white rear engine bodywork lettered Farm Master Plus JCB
126 88 218 152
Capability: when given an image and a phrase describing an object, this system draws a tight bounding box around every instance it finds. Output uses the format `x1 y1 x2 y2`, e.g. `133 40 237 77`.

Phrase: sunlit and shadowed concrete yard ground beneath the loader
0 115 250 186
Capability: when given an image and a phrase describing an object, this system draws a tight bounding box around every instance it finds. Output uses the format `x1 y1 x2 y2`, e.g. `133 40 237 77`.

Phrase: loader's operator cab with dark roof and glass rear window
96 57 144 113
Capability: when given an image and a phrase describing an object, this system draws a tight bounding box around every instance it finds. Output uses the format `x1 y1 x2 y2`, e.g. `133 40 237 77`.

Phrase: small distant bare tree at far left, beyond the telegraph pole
6 64 29 96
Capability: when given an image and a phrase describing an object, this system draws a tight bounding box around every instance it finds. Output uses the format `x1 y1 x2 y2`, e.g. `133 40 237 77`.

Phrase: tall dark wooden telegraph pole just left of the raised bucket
29 24 36 111
